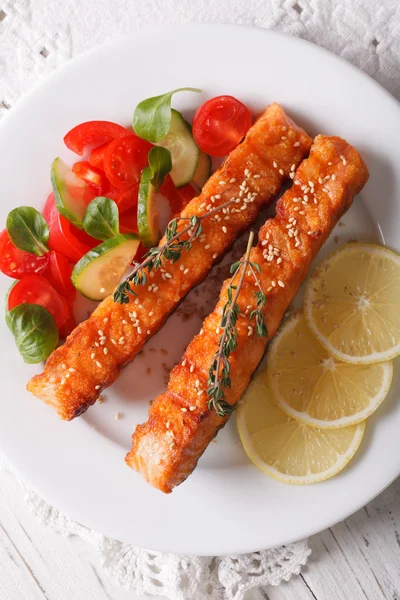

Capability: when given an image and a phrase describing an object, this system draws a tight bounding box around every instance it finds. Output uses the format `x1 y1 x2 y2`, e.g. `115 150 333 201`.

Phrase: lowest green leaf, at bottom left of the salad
6 303 58 364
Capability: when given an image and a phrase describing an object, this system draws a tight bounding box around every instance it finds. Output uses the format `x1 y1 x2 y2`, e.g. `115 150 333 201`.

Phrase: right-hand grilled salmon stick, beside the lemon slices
125 135 368 493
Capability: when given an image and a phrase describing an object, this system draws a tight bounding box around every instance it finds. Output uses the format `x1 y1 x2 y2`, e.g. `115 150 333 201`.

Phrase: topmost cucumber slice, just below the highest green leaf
158 109 200 187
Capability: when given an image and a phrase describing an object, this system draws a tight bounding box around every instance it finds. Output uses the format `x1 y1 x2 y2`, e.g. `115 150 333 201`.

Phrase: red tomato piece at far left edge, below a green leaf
0 229 49 279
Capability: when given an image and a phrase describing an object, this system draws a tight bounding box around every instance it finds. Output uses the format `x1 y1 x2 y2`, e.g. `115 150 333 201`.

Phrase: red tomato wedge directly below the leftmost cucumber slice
43 194 99 263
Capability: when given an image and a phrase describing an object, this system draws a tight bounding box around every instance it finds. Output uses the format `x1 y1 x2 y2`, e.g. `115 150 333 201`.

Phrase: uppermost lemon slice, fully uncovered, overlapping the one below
304 244 400 364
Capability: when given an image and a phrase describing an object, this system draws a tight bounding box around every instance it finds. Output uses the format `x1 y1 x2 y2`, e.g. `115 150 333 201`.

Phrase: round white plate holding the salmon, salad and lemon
0 25 400 555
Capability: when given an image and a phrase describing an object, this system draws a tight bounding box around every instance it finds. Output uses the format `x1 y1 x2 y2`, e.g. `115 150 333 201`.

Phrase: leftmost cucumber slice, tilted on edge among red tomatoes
51 158 87 229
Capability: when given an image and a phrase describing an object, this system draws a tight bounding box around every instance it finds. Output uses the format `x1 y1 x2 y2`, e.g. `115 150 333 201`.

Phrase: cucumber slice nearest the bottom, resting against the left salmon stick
71 233 140 302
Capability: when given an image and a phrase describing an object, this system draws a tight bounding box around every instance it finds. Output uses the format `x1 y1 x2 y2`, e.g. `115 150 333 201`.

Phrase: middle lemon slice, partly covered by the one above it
267 314 393 429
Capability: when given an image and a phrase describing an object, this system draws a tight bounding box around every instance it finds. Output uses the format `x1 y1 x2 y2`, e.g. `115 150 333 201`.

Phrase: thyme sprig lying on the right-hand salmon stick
207 232 268 417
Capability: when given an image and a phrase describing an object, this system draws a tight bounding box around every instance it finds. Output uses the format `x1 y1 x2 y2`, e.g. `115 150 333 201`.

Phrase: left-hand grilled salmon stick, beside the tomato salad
27 104 311 420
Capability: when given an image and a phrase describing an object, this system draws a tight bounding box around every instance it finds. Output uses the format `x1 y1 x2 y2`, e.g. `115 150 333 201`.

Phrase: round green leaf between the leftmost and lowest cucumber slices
83 196 119 242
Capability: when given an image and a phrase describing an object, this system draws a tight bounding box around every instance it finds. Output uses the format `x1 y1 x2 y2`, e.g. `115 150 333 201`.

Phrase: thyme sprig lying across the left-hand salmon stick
114 198 235 304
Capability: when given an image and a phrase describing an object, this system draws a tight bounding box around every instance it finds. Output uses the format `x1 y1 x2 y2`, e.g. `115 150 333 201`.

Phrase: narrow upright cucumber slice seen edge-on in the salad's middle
138 167 160 248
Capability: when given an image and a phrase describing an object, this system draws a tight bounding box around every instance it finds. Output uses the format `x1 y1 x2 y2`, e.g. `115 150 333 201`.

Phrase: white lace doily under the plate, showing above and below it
0 0 400 600
